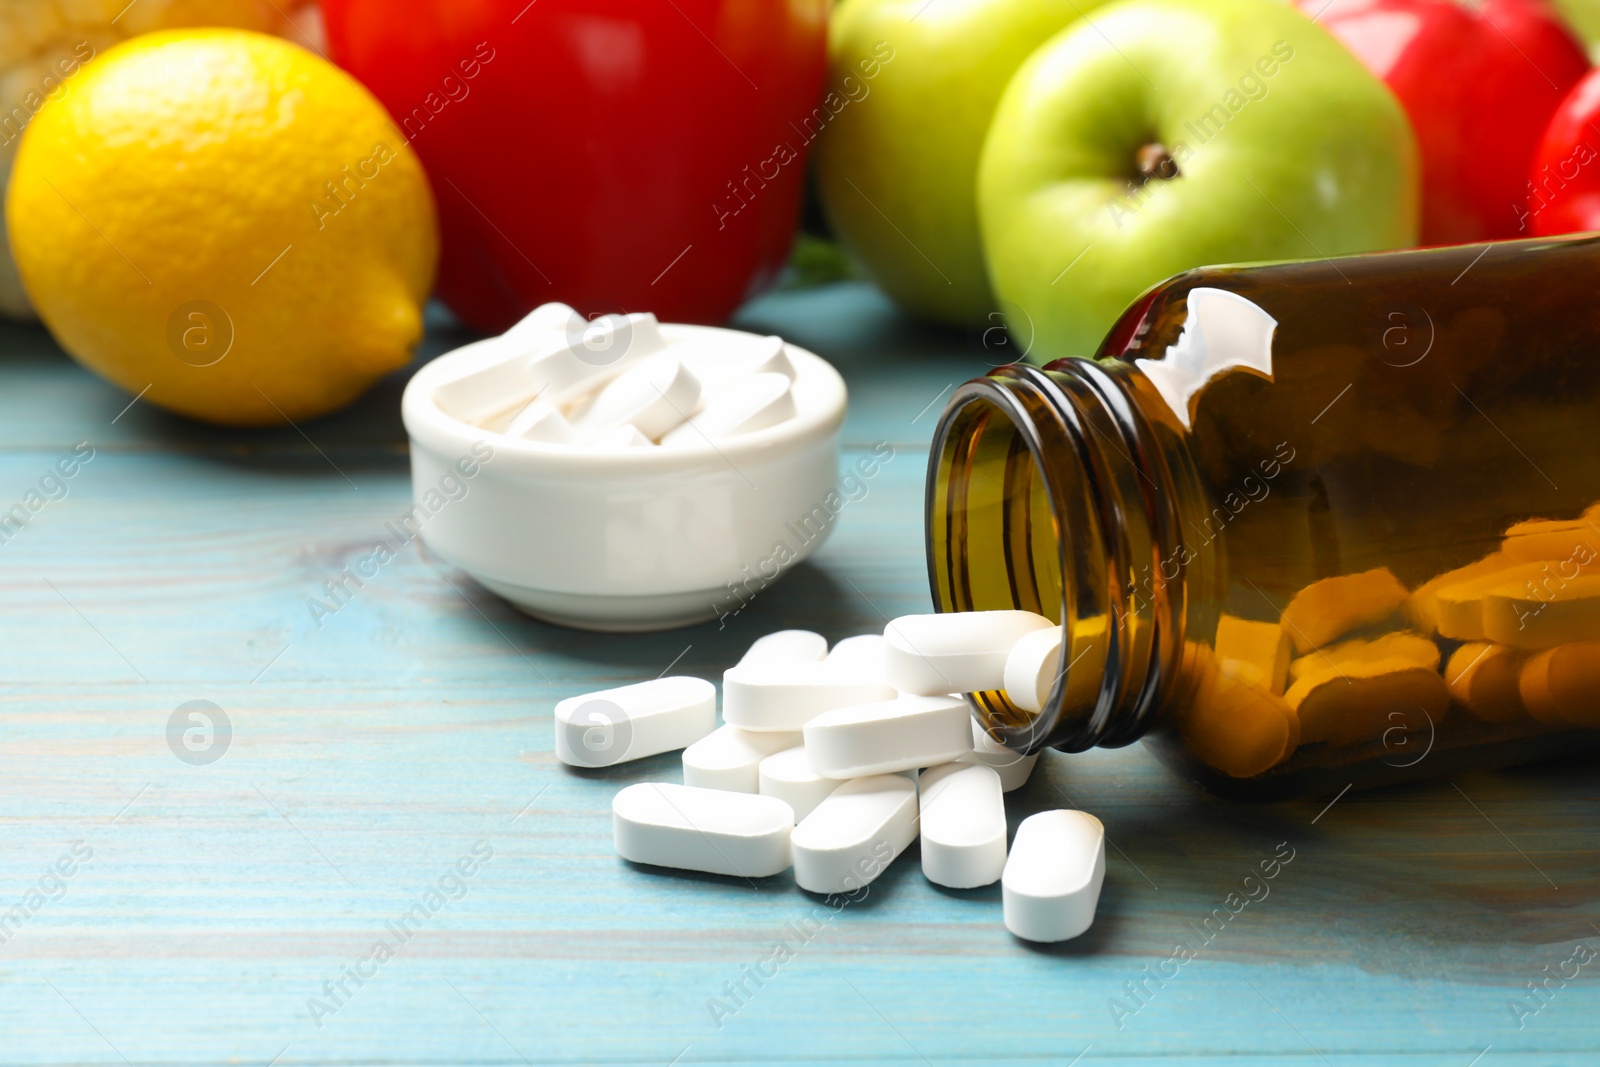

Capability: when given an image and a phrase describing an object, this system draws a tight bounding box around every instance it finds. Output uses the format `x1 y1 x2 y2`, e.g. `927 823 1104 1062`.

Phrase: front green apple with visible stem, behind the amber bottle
978 0 1419 362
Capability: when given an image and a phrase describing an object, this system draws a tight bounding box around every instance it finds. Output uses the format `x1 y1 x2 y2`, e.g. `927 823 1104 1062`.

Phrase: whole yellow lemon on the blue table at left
6 29 438 426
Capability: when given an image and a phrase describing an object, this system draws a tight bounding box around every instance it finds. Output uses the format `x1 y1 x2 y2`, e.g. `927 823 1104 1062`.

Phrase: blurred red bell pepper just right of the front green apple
1299 0 1589 245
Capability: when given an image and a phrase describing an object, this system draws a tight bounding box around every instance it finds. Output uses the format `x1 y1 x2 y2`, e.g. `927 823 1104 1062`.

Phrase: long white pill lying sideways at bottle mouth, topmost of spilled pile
883 611 1056 696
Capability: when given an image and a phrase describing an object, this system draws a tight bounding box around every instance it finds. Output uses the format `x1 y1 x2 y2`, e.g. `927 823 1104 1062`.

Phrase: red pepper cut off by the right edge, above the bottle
1526 70 1600 237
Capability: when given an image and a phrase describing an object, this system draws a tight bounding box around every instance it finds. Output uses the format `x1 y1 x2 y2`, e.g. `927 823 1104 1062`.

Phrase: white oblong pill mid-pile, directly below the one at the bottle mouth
803 696 973 777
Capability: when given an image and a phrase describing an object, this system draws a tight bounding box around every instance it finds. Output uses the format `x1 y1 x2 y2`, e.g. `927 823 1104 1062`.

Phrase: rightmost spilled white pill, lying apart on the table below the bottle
1000 809 1106 941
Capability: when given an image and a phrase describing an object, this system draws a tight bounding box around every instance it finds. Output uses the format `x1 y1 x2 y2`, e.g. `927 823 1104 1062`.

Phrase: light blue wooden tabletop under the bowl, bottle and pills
0 285 1600 1067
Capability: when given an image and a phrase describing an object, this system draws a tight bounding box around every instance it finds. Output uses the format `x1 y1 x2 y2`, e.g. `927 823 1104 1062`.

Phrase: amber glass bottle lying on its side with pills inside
926 238 1600 800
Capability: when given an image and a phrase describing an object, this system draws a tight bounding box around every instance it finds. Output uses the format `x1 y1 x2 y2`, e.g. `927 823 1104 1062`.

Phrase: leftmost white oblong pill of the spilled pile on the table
555 677 717 766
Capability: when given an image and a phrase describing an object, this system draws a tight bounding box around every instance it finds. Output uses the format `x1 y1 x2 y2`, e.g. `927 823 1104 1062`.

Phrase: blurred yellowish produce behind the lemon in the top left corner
0 0 322 318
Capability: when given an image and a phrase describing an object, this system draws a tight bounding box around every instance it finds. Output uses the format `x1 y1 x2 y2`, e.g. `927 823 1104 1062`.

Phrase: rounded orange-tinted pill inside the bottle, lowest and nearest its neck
1181 646 1299 777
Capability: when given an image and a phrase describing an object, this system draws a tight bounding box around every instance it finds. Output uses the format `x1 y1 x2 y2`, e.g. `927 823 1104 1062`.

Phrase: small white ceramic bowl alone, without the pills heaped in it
400 323 845 632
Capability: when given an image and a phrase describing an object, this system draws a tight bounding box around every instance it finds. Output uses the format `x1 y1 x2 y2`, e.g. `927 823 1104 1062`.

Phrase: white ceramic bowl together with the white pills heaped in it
402 304 845 630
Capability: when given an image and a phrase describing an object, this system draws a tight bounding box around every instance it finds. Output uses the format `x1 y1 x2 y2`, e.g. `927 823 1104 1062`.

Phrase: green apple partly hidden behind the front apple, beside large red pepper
806 0 1101 325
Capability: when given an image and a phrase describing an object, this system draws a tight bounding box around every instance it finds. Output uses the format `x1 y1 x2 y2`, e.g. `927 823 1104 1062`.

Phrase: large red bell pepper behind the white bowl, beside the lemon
320 0 827 331
